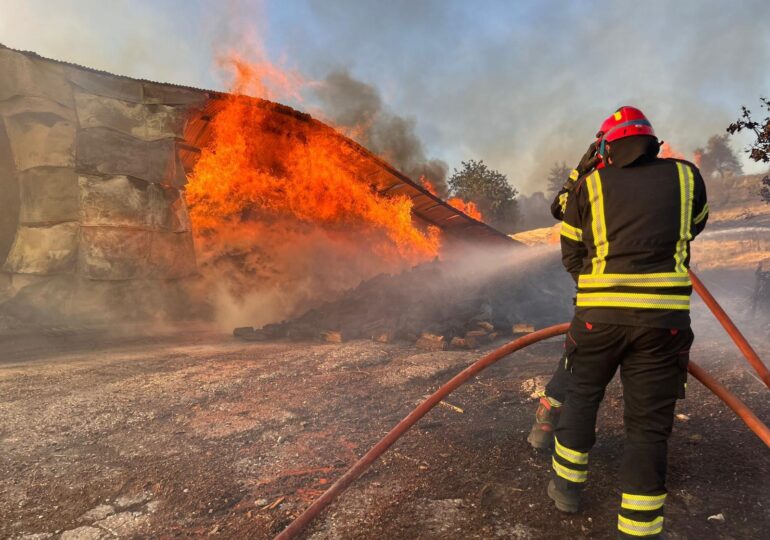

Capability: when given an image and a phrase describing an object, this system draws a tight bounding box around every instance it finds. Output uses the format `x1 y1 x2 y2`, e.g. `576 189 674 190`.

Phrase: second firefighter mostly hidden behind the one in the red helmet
527 142 603 450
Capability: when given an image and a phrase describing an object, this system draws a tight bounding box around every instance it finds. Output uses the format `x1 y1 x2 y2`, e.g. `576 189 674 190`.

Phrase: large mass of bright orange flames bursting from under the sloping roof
186 56 440 262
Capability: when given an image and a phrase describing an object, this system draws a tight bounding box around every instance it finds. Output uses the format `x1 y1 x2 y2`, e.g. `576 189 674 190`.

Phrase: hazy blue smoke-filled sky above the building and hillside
0 0 770 193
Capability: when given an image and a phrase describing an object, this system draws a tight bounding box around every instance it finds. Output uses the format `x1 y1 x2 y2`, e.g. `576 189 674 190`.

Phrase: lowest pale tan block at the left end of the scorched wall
3 223 79 275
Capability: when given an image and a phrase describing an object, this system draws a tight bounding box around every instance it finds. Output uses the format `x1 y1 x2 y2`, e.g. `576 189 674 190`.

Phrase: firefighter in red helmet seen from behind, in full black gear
547 107 708 538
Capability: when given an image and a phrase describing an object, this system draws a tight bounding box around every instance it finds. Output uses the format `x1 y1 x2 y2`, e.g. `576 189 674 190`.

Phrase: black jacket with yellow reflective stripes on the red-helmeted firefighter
561 158 708 328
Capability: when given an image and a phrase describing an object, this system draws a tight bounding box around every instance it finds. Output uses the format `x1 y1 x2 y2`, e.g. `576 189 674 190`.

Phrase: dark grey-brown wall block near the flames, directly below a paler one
77 128 187 187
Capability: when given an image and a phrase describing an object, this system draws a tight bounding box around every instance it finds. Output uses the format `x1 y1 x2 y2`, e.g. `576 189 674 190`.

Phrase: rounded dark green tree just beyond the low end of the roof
449 159 518 232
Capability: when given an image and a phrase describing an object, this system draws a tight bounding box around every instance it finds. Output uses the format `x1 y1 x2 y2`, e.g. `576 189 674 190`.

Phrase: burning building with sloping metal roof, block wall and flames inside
0 47 512 326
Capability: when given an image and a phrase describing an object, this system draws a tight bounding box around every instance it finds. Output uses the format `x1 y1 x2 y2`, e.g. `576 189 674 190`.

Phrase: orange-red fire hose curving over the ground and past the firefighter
275 272 770 540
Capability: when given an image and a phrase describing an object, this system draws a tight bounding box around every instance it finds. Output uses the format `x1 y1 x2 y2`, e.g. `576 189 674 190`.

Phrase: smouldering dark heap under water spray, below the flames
234 249 573 350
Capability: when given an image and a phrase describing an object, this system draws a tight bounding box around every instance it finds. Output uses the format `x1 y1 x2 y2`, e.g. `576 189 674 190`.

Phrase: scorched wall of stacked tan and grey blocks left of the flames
0 46 208 320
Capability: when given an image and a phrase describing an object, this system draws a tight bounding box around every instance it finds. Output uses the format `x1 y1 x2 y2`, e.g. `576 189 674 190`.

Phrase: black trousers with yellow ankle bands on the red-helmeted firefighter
553 317 693 538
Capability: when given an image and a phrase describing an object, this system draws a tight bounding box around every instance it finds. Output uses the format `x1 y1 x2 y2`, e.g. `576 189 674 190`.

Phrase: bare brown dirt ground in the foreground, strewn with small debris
0 312 770 540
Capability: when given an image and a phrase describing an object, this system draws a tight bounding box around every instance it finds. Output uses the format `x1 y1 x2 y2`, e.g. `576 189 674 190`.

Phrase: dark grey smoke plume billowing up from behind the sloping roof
315 69 449 197
